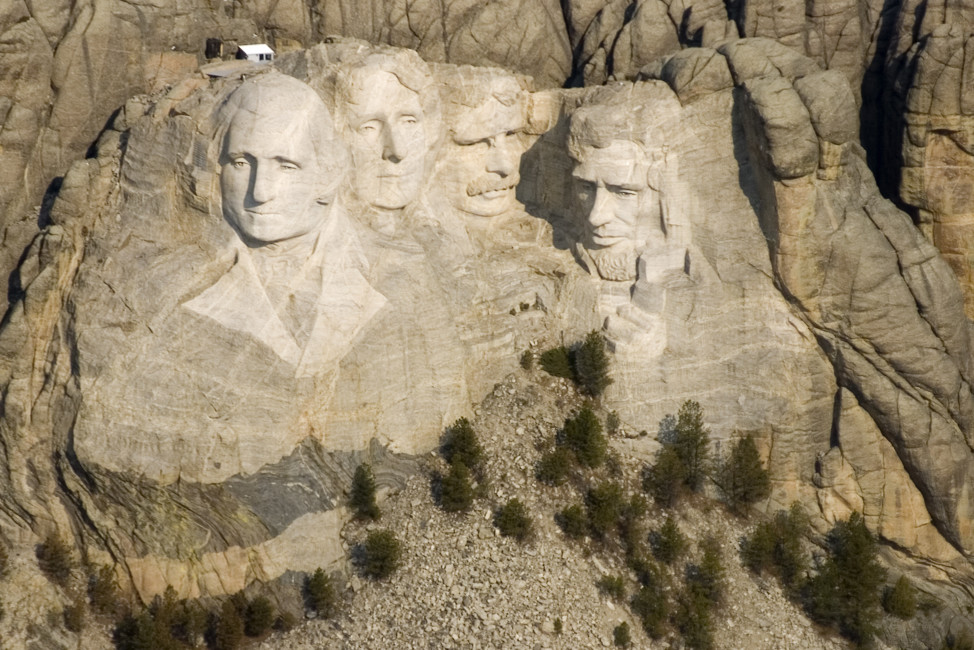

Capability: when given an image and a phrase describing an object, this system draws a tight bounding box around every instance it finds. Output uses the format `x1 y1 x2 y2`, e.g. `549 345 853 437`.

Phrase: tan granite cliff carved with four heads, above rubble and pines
0 2 974 644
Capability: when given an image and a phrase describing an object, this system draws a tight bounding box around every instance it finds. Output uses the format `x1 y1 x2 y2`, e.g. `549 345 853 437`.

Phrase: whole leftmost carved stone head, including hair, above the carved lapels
220 73 347 246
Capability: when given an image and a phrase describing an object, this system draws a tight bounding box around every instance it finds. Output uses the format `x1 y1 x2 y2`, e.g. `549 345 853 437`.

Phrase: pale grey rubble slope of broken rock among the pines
261 371 847 650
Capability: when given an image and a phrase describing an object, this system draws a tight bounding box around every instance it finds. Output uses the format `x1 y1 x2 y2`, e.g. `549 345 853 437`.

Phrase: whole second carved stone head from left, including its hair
336 50 439 210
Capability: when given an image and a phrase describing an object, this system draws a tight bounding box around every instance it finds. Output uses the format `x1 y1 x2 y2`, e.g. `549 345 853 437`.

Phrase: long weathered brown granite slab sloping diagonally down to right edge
728 41 974 550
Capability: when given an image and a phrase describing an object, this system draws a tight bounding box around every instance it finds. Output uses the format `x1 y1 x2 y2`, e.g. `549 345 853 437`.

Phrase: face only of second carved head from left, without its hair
345 68 430 210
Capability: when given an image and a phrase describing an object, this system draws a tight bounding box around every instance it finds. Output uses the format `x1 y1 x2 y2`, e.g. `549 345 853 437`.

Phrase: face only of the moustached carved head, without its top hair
440 97 526 217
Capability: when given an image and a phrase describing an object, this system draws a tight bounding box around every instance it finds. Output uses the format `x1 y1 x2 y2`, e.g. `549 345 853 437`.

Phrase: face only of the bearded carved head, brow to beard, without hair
572 140 657 280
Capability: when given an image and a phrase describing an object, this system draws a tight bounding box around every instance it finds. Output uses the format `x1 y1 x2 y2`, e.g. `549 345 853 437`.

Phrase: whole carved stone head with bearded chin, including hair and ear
568 84 674 281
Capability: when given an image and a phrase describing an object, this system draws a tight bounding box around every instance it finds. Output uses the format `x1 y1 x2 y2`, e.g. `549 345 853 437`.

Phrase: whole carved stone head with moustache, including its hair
439 66 527 217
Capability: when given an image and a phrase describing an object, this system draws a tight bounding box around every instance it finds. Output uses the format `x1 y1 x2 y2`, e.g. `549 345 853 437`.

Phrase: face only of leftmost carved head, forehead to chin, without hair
220 93 327 245
